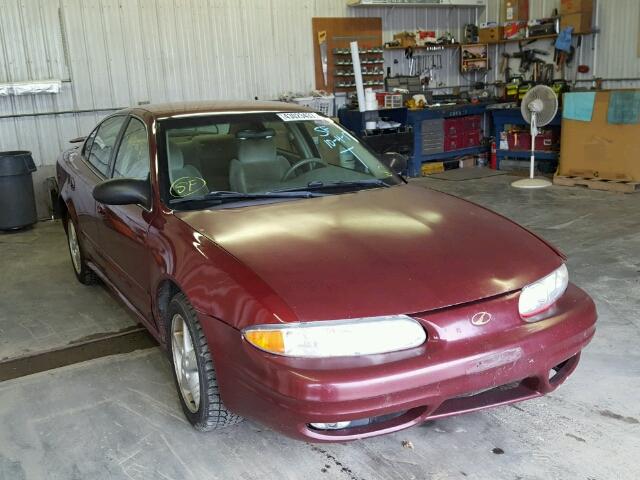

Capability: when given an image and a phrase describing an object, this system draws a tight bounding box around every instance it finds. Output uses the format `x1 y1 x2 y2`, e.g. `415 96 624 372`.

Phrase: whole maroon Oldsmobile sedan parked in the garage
57 102 596 441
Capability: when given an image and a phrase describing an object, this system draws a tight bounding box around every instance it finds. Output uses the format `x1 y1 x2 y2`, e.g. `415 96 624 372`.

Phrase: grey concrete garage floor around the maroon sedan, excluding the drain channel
0 176 640 480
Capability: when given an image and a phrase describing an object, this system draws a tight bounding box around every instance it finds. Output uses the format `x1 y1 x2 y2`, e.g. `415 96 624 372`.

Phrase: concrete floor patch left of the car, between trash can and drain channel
0 221 137 360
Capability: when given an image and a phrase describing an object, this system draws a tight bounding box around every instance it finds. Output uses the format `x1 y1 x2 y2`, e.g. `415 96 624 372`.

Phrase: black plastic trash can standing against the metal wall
0 150 38 230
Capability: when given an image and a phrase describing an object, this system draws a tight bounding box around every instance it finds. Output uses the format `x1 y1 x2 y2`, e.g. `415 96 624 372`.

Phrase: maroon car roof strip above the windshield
127 100 313 118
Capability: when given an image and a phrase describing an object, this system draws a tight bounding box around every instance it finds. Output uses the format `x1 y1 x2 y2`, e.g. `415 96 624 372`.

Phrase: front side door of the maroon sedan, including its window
96 117 152 318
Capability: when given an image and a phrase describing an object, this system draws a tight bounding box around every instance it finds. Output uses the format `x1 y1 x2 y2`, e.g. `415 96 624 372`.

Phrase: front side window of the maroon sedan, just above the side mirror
113 118 150 180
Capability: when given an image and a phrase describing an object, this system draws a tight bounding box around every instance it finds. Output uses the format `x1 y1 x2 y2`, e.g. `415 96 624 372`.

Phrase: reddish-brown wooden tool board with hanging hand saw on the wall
312 17 384 92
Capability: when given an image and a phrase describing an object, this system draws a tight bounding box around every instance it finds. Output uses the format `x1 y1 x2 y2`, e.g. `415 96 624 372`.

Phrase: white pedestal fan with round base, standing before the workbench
511 85 558 188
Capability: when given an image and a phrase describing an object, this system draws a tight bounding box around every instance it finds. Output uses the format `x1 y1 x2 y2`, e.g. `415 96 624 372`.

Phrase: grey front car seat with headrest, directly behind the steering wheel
229 129 291 193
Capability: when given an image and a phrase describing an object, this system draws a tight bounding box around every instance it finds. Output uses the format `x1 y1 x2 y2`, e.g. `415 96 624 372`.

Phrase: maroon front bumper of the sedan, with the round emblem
200 284 596 442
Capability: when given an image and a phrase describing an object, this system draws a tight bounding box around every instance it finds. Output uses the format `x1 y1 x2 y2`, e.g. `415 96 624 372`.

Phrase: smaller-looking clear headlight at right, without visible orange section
518 263 569 320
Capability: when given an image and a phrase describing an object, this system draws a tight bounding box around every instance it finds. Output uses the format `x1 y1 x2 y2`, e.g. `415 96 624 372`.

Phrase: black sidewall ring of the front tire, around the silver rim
167 298 209 426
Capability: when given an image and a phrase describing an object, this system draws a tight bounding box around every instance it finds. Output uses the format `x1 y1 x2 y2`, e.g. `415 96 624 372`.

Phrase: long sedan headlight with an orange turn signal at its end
242 315 427 358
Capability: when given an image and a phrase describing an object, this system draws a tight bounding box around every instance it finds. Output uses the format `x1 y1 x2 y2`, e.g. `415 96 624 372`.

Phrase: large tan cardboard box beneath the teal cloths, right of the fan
558 90 640 181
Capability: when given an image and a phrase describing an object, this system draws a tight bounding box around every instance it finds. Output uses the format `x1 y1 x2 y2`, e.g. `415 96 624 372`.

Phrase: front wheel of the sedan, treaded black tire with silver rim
167 293 243 432
